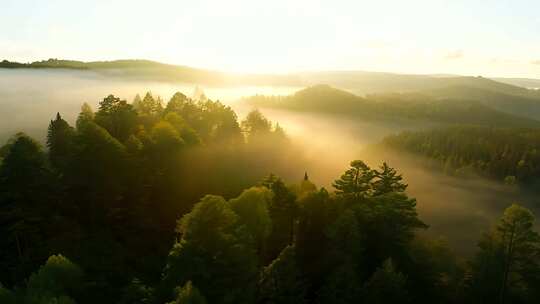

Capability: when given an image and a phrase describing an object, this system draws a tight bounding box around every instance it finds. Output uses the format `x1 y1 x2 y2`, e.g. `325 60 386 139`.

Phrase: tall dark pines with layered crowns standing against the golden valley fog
330 160 427 272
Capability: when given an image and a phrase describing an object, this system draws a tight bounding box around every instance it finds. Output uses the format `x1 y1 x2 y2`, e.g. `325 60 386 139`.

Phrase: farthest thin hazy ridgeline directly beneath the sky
4 59 540 92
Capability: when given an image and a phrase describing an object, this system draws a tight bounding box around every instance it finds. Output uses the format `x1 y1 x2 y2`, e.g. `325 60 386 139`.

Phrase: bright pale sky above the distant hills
0 0 540 78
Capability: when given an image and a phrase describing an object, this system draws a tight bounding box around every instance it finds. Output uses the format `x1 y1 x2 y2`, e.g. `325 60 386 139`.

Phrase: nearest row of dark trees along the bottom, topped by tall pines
0 160 540 304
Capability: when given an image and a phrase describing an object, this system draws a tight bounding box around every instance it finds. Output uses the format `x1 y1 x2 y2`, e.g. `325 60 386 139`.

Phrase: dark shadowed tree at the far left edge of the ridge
0 133 52 280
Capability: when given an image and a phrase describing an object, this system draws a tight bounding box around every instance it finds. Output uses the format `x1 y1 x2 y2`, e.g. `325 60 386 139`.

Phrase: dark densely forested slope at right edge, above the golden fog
383 126 540 185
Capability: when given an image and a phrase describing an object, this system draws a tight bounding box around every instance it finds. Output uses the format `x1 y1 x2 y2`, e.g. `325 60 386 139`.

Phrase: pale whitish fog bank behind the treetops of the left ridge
0 69 298 143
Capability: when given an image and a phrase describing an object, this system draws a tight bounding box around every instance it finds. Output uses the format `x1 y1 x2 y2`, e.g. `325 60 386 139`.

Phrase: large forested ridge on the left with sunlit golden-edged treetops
0 93 296 303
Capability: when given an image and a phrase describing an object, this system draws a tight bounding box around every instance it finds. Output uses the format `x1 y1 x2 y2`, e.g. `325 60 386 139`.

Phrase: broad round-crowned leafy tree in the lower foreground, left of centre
164 195 257 303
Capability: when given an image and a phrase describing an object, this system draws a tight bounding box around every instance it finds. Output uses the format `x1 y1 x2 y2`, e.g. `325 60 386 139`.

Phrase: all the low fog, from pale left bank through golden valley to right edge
4 69 540 254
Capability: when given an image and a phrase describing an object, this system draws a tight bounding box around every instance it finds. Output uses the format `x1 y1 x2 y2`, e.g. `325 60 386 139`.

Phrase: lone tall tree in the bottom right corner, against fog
470 204 540 303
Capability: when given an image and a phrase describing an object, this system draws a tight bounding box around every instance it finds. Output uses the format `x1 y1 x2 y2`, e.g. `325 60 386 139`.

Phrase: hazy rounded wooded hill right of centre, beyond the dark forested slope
245 85 540 127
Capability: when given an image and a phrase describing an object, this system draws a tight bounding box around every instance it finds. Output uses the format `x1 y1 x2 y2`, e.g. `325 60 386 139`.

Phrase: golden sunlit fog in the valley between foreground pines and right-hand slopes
247 109 540 256
